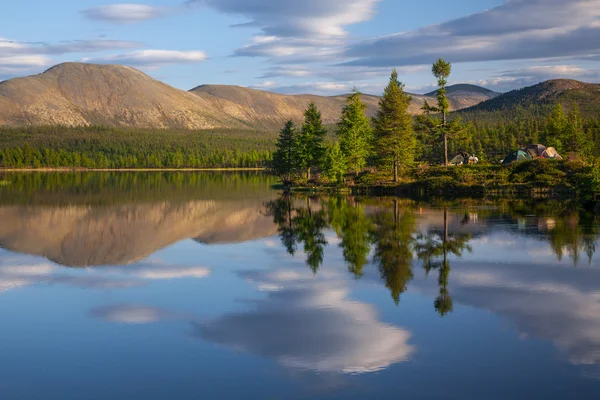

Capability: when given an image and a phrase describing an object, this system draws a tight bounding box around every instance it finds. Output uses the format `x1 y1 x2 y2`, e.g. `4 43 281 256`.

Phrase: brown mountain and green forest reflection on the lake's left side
0 174 275 266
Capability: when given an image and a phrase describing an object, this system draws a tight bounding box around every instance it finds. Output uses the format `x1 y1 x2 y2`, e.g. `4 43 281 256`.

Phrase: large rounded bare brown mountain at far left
0 63 244 129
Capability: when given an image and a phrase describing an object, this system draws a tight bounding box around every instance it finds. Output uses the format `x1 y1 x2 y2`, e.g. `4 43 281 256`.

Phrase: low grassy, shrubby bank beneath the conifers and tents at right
297 160 600 211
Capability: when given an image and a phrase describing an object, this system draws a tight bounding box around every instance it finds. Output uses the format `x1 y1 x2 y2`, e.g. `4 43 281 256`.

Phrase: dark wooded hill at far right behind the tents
461 79 600 116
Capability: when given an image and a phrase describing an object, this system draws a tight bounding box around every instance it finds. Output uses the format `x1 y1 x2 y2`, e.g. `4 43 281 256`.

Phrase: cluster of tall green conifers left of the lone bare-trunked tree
272 70 416 185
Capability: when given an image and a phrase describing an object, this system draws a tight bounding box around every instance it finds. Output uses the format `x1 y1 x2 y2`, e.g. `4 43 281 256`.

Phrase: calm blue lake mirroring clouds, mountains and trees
0 173 600 400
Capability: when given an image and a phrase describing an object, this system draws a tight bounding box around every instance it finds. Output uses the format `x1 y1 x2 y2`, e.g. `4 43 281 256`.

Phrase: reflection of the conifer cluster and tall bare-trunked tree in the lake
265 195 471 315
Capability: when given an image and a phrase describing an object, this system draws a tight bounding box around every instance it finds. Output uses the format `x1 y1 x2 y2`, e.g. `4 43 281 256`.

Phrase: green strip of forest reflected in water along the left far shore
0 171 275 205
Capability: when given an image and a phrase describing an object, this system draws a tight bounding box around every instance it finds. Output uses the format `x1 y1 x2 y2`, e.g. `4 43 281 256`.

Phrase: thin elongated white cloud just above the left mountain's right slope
83 50 208 67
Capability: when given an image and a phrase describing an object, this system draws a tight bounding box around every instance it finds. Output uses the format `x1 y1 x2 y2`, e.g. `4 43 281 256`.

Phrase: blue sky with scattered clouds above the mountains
0 0 600 94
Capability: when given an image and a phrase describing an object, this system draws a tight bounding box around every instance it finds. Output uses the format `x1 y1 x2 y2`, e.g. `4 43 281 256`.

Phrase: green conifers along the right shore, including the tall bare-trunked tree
272 59 600 185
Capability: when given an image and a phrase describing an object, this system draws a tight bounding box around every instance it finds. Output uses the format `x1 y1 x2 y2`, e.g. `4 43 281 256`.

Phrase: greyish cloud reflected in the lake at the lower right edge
414 261 600 365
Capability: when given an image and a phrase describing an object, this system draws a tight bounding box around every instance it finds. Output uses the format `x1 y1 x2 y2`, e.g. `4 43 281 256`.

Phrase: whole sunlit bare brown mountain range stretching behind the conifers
0 63 497 130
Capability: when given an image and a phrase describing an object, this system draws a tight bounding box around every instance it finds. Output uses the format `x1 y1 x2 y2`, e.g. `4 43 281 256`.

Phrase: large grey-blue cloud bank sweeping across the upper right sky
346 0 600 66
